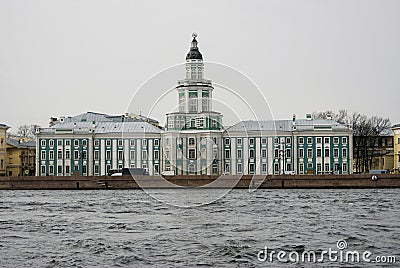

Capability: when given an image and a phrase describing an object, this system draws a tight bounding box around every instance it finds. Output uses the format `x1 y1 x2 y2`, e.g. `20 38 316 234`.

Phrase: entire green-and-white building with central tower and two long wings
36 35 353 176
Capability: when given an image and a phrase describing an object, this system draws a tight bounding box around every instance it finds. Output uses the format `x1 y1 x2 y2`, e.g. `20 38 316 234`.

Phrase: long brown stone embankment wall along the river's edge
0 174 400 190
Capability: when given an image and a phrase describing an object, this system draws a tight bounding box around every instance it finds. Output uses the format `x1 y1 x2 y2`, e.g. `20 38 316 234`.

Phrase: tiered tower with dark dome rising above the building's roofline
166 33 222 130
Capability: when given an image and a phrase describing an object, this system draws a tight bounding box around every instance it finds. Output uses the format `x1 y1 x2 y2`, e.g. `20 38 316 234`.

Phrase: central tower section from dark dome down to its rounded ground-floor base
162 33 223 175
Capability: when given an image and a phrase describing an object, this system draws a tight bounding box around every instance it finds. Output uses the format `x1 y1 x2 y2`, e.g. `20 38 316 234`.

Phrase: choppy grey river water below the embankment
0 189 400 267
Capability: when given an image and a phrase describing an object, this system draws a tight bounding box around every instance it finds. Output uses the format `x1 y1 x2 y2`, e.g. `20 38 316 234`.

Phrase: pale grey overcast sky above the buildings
0 0 400 131
